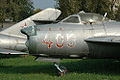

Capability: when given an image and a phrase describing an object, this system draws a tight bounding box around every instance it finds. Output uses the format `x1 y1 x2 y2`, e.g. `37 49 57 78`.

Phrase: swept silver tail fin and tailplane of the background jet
0 8 61 38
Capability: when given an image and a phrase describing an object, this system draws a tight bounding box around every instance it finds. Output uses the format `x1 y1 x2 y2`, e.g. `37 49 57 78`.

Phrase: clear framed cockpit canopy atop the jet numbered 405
61 13 108 24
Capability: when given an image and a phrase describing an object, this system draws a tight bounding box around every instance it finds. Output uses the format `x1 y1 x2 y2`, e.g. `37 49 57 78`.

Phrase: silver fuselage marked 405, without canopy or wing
22 21 120 58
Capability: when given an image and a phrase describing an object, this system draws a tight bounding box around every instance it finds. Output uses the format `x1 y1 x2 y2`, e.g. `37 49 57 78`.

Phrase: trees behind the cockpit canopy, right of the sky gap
56 0 120 19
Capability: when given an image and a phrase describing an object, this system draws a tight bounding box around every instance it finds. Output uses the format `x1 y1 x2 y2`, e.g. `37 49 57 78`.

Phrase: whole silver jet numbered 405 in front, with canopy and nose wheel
21 13 120 74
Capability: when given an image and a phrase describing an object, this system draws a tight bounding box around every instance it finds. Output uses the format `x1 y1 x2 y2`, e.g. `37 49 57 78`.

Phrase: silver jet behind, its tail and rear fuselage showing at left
0 8 61 54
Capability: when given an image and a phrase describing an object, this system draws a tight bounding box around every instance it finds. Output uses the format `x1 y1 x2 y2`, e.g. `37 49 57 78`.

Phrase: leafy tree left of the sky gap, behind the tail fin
0 0 33 21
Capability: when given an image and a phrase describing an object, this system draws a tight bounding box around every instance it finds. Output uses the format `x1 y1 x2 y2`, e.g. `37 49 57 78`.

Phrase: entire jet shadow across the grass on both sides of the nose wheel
0 59 120 76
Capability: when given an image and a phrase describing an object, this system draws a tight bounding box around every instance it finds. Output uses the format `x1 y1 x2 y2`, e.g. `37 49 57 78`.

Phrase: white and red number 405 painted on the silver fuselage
42 34 76 48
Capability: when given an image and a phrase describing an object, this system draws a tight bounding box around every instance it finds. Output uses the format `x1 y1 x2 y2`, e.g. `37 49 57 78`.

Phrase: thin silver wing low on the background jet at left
0 49 28 55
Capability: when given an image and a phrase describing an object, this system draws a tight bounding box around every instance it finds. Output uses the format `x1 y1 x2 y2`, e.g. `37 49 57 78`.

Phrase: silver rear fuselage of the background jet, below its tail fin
0 34 27 51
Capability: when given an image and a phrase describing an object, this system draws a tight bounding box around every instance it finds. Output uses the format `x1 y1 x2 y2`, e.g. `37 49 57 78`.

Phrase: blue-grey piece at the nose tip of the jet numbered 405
21 26 36 37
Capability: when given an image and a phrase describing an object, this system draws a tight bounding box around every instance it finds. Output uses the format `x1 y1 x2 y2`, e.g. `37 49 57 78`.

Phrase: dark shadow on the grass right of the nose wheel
63 59 120 75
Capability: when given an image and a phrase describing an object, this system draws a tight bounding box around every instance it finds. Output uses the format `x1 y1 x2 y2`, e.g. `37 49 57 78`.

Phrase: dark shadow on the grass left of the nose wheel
0 64 55 75
